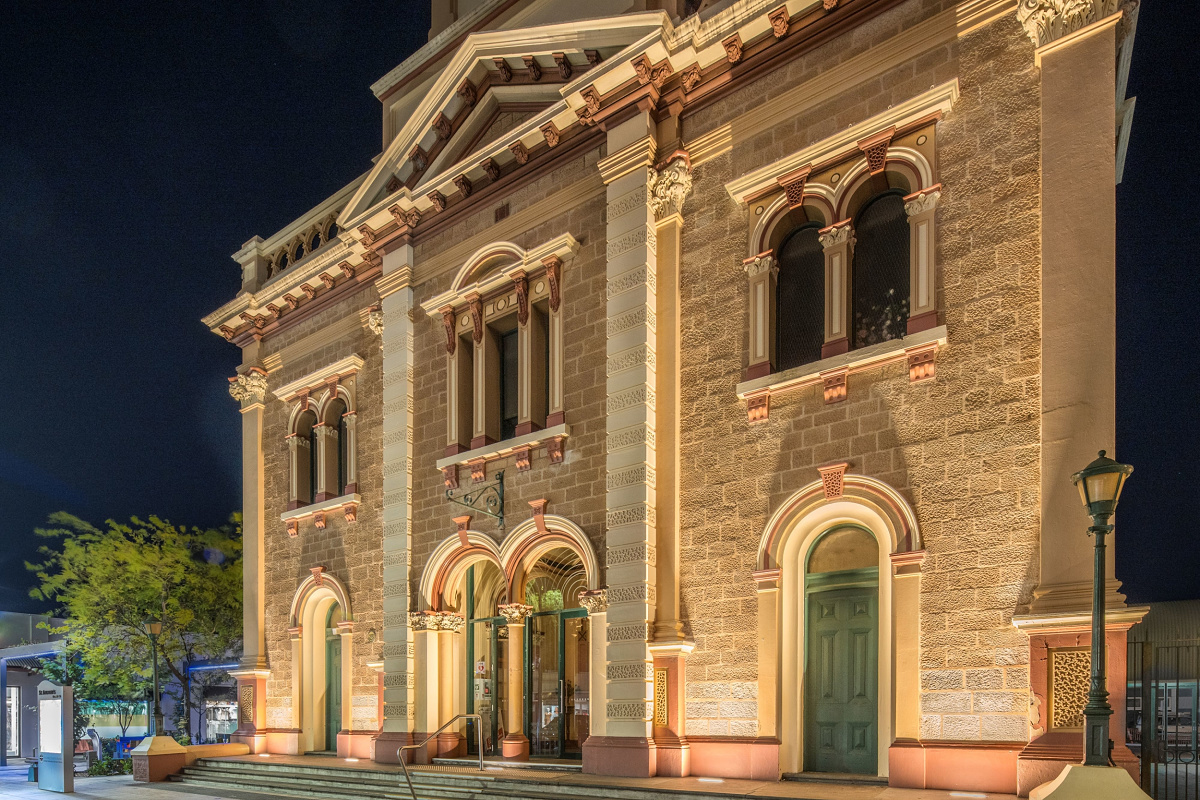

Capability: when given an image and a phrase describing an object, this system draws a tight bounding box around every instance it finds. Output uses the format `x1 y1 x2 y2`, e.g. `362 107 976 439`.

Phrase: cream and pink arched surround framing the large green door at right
755 474 924 776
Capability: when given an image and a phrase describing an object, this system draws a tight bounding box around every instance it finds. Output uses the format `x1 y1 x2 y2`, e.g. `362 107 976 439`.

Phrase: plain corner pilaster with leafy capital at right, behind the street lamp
1018 0 1124 612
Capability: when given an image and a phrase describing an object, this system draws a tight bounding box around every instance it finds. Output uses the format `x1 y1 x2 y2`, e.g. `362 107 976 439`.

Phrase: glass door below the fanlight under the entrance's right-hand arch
526 608 589 758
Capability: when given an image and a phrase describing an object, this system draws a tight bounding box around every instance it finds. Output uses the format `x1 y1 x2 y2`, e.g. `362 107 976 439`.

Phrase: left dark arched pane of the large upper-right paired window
775 222 824 371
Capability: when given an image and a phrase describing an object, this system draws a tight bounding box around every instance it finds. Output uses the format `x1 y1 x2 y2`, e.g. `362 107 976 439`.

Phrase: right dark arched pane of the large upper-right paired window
851 190 910 348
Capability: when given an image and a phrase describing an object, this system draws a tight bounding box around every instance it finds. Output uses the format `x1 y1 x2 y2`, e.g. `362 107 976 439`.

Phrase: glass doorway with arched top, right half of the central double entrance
520 547 590 758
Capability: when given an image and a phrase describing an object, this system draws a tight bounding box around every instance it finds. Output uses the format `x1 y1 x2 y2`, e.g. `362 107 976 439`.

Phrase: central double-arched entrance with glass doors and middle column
415 515 602 759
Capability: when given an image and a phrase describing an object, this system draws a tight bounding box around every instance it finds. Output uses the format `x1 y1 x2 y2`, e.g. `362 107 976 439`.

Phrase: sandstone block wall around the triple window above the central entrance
412 149 606 608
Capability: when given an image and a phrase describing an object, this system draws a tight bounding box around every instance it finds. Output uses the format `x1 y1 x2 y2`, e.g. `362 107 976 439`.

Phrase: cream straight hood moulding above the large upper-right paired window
725 78 959 204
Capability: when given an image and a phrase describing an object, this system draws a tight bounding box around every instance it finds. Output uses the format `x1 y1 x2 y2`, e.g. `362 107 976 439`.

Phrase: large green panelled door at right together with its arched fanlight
804 525 880 775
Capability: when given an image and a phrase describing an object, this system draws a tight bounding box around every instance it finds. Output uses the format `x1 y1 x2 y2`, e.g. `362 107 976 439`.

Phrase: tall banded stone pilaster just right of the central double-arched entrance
595 112 658 777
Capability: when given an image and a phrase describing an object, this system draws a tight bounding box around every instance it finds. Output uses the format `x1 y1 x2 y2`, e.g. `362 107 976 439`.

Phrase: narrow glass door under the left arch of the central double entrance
467 616 508 756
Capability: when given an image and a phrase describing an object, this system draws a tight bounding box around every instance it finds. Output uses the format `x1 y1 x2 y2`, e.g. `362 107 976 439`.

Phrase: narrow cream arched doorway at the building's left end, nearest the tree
289 567 354 754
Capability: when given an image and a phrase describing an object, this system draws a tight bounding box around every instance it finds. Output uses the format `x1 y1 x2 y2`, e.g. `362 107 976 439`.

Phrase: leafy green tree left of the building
26 512 241 736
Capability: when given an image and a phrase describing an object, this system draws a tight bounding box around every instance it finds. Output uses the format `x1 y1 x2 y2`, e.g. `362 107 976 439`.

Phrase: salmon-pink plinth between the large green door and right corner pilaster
888 739 1025 794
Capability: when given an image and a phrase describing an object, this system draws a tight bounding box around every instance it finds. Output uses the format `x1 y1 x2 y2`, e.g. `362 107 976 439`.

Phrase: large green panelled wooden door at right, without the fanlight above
804 587 878 775
